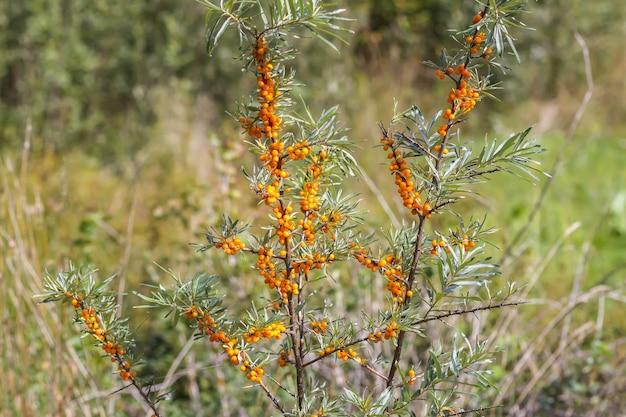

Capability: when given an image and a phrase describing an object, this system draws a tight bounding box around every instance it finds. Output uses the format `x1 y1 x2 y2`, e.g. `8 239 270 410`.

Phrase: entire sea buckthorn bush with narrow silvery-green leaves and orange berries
37 0 541 416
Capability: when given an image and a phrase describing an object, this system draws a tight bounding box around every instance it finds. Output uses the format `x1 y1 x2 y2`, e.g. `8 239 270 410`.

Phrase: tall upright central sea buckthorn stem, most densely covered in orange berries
186 0 356 413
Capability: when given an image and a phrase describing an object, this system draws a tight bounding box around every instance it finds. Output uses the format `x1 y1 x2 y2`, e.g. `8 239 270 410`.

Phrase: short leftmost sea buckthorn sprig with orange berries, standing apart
37 264 162 417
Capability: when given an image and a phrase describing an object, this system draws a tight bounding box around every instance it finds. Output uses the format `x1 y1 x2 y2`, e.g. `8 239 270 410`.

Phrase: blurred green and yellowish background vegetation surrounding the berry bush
0 0 626 416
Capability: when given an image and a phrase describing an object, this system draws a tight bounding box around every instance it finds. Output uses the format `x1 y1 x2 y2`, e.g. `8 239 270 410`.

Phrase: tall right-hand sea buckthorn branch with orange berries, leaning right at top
364 0 542 413
